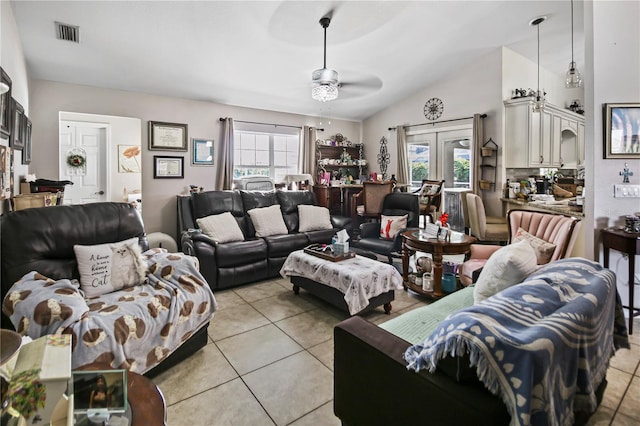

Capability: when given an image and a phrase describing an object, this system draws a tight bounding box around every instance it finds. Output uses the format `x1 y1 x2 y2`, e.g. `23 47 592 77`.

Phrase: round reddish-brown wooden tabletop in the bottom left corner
78 363 167 426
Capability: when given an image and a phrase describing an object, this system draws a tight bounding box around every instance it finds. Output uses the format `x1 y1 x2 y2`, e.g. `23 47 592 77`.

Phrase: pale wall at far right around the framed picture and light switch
584 1 640 307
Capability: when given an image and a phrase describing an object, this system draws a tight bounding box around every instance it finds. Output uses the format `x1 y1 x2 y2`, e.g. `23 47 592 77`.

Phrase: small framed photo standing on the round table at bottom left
70 370 127 417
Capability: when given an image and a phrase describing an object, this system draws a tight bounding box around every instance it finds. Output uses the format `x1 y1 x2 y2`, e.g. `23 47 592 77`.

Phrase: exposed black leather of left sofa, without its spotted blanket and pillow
0 203 208 376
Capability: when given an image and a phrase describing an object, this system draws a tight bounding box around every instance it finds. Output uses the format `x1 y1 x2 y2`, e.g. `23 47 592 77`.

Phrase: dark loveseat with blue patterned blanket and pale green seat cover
334 258 629 425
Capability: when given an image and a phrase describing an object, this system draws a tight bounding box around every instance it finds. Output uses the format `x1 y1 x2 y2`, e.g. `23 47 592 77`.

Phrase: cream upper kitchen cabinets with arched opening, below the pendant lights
505 98 584 169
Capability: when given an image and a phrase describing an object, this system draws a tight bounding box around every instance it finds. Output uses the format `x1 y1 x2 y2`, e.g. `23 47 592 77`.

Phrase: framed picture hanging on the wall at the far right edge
604 103 640 159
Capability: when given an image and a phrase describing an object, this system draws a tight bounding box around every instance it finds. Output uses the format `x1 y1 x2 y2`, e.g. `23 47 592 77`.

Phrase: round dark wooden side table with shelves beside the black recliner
402 230 476 298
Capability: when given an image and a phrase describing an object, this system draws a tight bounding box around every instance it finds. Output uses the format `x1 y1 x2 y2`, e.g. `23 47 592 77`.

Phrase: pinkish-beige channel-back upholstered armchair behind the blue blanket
459 209 581 286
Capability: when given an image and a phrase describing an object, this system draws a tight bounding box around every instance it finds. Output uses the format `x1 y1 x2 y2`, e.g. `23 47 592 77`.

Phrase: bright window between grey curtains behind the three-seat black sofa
233 130 299 182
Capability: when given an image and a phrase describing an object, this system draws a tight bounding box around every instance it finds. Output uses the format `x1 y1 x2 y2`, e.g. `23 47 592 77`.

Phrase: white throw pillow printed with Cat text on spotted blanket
73 237 147 297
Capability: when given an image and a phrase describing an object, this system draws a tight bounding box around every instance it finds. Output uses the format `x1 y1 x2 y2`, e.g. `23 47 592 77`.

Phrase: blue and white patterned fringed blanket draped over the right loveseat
404 258 629 425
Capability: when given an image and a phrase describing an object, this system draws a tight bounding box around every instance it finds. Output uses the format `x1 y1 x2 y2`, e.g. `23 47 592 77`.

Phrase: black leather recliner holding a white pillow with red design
353 192 420 263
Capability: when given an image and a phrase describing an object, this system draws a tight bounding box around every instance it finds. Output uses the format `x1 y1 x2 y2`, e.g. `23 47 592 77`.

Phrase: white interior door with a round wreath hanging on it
60 121 108 204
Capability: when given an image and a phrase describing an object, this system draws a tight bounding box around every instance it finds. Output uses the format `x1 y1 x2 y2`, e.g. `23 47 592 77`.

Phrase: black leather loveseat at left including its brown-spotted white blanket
0 203 216 375
